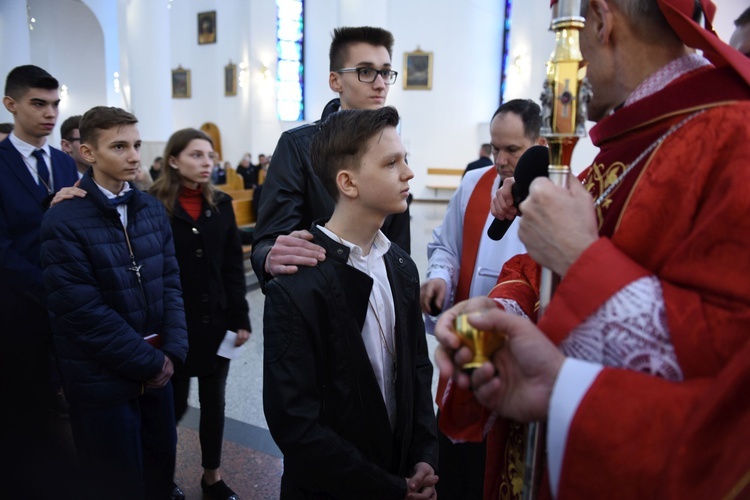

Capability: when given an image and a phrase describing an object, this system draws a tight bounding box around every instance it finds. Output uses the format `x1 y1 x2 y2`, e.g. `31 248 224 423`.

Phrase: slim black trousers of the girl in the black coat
172 357 229 469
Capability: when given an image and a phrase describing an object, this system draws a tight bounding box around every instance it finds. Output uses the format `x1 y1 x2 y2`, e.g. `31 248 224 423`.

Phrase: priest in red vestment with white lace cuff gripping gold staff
438 0 750 498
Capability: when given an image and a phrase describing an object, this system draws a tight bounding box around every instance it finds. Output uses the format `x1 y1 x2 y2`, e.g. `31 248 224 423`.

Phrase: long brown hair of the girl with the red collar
149 128 216 217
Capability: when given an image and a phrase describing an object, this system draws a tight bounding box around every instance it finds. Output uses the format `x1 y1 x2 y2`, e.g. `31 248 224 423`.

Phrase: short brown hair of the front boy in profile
310 106 399 202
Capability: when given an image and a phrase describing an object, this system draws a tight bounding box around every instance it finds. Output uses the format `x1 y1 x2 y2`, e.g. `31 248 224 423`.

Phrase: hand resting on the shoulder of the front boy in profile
265 230 326 276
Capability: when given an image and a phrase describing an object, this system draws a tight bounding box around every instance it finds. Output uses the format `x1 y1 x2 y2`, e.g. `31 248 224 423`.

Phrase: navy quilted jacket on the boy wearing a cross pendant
41 173 188 404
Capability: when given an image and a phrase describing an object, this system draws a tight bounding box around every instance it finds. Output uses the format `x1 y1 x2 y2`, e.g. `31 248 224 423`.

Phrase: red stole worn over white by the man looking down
454 168 497 303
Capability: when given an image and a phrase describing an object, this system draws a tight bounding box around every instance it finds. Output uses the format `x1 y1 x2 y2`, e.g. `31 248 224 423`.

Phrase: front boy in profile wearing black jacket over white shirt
263 107 437 499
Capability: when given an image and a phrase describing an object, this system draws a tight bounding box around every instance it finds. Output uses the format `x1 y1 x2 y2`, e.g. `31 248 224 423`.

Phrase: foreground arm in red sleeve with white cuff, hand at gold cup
436 304 750 499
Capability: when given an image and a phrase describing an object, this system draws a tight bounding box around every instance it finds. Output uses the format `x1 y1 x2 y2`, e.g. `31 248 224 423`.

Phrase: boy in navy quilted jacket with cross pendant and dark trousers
42 106 187 499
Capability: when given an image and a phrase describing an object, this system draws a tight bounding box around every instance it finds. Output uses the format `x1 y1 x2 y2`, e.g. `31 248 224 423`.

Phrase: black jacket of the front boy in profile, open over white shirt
263 227 437 500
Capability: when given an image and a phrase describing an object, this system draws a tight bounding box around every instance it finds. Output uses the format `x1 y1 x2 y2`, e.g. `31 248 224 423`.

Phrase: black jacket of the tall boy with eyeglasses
251 99 411 289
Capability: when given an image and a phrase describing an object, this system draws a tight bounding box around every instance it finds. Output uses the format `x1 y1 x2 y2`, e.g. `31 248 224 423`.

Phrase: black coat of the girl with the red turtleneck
172 191 250 376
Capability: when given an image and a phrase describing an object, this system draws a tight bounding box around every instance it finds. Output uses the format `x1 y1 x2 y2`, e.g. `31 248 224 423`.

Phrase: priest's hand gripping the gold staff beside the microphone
518 176 599 276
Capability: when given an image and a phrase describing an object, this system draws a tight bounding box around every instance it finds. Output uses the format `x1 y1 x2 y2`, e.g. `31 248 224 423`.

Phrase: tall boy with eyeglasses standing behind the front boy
252 26 411 289
